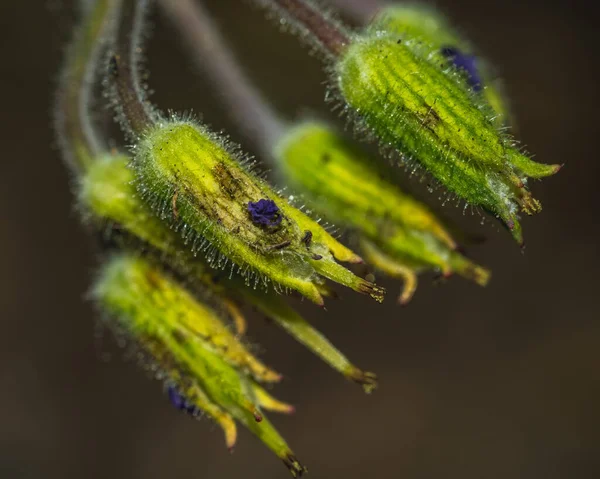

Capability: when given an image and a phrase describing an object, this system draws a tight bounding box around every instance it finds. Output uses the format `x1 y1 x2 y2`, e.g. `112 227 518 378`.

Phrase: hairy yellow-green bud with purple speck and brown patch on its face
134 122 383 304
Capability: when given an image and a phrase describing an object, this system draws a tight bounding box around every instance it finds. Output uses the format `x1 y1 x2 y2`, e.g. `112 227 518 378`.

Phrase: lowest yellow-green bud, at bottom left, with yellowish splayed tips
94 256 304 476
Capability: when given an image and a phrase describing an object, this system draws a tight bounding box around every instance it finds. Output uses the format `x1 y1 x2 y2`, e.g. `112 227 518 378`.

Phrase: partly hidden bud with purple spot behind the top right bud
370 4 509 127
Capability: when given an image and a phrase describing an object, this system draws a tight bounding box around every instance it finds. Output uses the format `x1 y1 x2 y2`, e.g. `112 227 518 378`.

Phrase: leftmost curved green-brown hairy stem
55 0 116 173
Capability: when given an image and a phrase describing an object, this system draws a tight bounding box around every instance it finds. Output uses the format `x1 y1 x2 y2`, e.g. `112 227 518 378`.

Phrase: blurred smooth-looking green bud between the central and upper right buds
275 123 489 303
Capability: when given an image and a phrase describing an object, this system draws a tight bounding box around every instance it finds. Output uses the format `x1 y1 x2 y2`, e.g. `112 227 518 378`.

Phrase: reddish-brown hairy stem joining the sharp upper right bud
255 0 350 57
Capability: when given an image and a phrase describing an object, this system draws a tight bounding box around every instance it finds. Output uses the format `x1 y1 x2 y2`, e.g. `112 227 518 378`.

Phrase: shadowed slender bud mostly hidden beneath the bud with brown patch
79 155 376 391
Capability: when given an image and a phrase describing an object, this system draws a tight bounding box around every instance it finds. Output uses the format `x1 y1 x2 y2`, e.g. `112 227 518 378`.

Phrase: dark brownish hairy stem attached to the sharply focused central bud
109 0 155 137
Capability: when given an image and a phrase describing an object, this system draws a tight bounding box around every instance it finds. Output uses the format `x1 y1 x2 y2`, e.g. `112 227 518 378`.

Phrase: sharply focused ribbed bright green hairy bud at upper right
334 29 560 243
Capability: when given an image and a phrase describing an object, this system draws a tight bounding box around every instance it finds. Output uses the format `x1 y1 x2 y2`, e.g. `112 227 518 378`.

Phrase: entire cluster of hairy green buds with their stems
56 0 559 475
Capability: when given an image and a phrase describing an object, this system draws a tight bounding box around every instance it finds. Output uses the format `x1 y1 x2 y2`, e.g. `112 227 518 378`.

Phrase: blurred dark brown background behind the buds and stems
0 0 600 479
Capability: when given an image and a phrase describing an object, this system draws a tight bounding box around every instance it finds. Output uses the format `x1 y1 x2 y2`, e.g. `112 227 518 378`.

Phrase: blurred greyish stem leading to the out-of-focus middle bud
159 0 283 156
